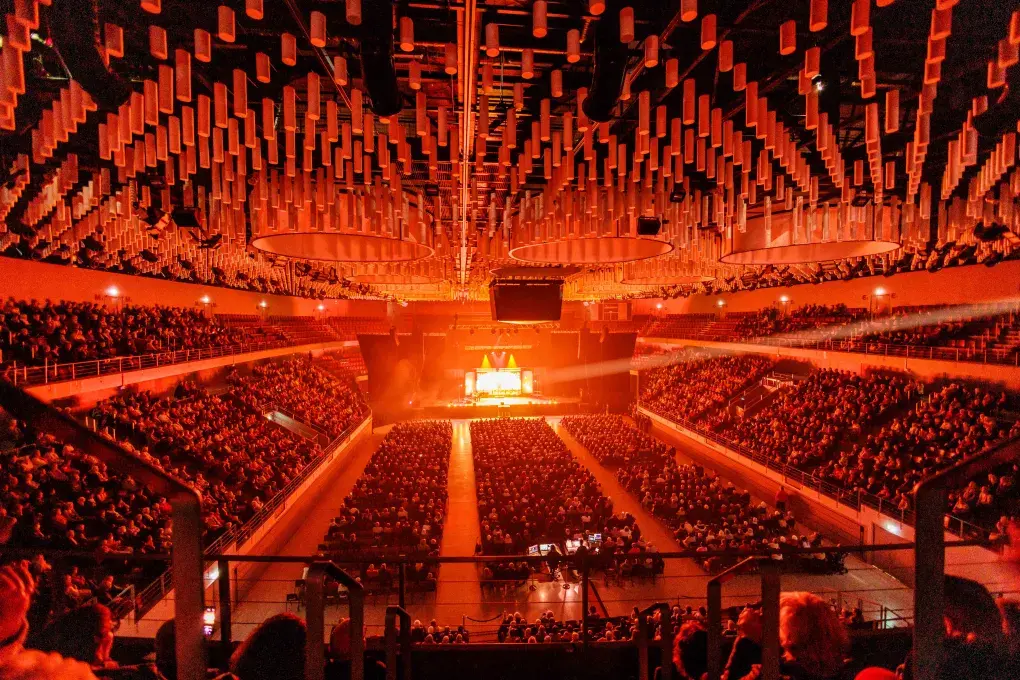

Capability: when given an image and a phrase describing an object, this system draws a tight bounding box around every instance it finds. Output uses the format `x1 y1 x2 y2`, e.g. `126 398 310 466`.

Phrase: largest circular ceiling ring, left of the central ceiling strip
250 231 434 262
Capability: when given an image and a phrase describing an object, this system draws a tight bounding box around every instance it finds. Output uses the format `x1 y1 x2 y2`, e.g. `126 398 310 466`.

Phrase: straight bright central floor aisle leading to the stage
432 420 481 625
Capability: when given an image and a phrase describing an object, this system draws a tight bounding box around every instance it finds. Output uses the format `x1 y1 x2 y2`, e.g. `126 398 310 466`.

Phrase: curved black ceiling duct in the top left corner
49 0 132 110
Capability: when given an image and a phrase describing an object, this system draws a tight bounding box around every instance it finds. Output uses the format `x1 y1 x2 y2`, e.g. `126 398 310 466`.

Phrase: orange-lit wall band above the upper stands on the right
633 262 1020 314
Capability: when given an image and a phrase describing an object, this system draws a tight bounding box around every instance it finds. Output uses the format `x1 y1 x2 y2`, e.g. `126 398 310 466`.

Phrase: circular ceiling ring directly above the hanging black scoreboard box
510 237 673 265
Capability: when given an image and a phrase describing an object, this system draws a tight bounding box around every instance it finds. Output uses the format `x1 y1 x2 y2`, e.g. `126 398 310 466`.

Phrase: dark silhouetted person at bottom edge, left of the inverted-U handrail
231 614 306 680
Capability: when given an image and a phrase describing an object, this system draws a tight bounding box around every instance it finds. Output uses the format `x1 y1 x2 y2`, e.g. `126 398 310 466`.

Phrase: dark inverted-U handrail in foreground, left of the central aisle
305 562 365 680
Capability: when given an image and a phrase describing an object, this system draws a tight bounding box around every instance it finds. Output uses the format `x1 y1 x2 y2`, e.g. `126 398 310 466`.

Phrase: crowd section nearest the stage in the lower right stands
641 350 772 422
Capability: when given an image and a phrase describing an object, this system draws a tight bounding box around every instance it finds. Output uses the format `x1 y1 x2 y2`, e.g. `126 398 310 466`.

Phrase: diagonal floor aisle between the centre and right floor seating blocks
549 418 709 616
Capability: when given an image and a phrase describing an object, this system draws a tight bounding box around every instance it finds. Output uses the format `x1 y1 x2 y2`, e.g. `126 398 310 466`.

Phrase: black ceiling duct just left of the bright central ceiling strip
361 0 403 117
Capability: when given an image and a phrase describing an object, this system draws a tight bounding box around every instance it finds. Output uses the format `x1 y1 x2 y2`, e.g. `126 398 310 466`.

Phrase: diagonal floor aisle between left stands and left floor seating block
232 426 390 640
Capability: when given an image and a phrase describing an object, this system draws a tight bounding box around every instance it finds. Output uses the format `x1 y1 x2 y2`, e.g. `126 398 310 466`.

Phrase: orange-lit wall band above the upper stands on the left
0 257 386 316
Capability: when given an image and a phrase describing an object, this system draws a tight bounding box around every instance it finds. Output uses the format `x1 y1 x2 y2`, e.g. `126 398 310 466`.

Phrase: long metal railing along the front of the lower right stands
638 404 995 538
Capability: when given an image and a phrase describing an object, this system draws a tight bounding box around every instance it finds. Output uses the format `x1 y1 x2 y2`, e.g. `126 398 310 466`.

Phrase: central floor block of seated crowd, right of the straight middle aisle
471 418 647 568
